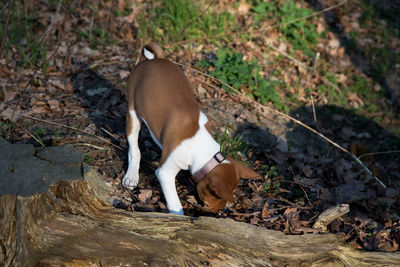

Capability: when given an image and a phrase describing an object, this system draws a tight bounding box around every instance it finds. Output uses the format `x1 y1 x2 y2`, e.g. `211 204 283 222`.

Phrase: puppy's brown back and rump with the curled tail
128 43 200 162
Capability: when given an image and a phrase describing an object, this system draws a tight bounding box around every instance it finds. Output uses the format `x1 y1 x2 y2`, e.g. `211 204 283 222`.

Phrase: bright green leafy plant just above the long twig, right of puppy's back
198 48 282 109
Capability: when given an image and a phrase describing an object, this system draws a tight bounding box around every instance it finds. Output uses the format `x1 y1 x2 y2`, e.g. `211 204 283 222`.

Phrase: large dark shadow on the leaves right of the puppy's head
233 105 400 219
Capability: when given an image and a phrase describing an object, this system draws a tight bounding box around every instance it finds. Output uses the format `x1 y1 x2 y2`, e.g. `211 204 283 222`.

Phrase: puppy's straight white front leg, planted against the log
156 165 183 215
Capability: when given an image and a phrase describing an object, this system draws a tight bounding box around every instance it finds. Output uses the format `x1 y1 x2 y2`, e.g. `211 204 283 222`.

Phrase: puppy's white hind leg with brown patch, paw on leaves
122 110 140 189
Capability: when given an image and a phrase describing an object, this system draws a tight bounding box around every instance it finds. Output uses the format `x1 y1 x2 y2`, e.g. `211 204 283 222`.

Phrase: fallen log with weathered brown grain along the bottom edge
0 170 400 266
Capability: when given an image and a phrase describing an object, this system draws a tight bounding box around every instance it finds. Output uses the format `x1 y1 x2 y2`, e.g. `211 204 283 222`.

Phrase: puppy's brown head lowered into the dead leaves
197 158 260 213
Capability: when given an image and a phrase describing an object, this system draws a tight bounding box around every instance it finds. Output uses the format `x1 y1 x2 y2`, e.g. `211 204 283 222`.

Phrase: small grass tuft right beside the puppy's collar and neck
215 127 249 159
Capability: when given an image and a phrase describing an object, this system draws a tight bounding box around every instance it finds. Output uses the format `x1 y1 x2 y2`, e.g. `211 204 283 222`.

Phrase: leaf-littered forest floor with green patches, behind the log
0 0 400 251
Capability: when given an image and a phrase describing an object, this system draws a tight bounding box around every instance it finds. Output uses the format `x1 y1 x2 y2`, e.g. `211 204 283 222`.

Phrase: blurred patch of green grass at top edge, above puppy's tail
140 0 234 44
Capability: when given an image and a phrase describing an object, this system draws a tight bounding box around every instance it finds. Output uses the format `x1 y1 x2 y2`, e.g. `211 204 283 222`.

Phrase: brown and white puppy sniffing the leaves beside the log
122 43 259 214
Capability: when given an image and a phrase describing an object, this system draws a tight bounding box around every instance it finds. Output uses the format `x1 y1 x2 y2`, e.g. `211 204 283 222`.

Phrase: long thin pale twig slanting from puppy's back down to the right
175 62 387 189
